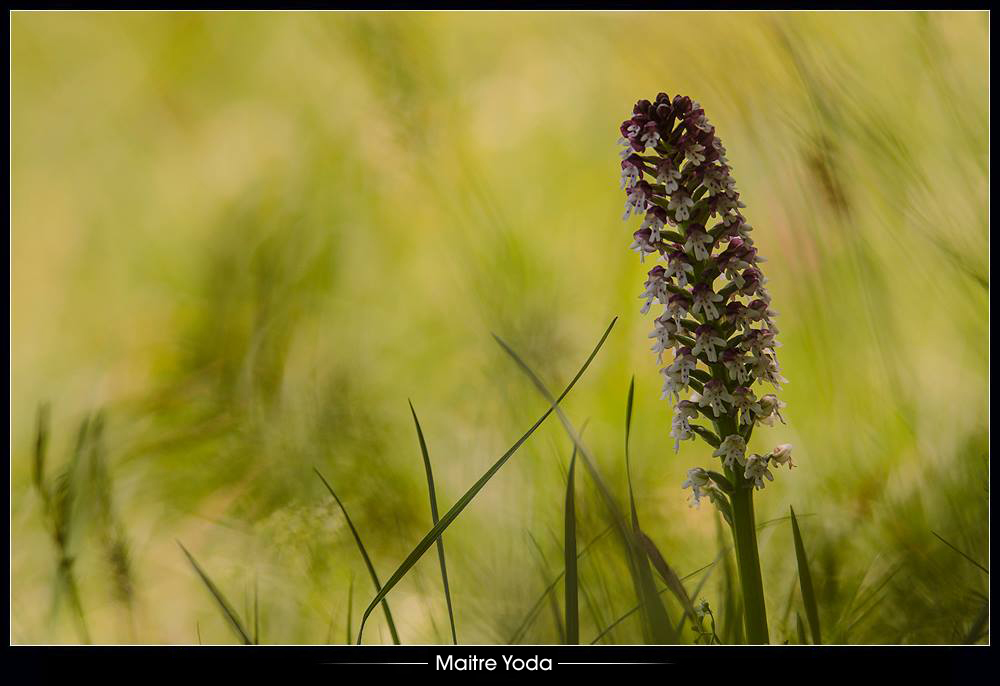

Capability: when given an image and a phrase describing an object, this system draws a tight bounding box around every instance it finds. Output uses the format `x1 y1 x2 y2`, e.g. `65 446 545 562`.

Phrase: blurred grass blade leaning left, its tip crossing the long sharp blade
493 344 676 645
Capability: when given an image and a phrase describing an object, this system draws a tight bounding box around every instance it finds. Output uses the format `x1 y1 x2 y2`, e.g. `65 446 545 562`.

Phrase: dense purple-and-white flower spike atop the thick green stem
619 93 793 504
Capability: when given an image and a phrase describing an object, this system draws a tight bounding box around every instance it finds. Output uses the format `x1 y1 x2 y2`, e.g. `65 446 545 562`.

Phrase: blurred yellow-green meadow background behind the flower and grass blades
10 12 989 643
